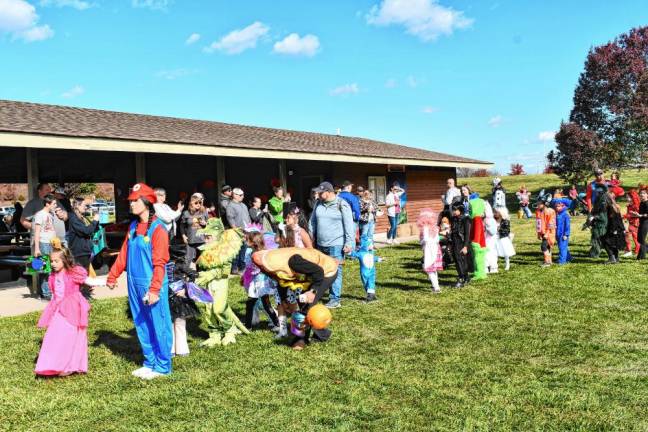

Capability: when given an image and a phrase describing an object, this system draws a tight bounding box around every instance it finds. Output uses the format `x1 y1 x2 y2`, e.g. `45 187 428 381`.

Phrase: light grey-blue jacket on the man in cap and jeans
308 198 355 249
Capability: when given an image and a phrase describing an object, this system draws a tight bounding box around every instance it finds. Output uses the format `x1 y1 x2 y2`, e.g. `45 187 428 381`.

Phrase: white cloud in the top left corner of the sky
0 0 54 42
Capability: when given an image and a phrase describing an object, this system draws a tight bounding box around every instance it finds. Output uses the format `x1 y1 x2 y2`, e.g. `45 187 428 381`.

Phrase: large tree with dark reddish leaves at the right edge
548 27 648 181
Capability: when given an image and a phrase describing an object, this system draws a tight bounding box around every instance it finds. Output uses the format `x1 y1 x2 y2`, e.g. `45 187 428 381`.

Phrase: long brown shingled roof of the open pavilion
0 100 488 164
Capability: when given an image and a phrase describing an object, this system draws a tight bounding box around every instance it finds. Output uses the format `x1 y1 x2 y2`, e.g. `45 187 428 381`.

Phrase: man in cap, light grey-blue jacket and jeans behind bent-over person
309 182 355 309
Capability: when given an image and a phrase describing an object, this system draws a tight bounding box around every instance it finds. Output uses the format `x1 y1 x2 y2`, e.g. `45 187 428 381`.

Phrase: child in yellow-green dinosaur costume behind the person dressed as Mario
196 218 250 347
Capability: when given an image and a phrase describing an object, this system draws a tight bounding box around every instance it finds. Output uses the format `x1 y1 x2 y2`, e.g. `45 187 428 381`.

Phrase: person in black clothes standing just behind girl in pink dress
68 197 99 271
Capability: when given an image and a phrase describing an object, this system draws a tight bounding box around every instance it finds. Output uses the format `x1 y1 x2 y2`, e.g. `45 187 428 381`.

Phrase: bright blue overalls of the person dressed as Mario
126 219 173 374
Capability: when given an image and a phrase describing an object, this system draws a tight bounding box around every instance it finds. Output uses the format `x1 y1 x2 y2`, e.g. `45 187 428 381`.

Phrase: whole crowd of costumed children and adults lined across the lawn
23 171 648 379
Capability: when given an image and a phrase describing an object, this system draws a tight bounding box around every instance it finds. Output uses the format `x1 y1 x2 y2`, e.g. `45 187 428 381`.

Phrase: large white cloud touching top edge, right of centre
366 0 474 42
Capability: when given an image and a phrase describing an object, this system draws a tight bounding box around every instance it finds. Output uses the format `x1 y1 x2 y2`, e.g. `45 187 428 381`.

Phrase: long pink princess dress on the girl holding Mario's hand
34 266 90 375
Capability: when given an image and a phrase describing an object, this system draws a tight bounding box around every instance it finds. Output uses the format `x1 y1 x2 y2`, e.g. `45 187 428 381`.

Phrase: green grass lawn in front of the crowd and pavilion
0 220 648 431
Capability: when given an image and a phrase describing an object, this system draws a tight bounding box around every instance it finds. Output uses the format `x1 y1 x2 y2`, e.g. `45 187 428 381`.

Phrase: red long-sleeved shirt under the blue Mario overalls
107 218 169 294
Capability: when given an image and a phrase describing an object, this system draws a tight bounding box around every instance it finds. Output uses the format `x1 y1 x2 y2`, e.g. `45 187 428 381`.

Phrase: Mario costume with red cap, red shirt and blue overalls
107 183 173 379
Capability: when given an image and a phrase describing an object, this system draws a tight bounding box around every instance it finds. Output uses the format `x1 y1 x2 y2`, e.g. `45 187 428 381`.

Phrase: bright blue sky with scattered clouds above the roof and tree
0 0 648 172
